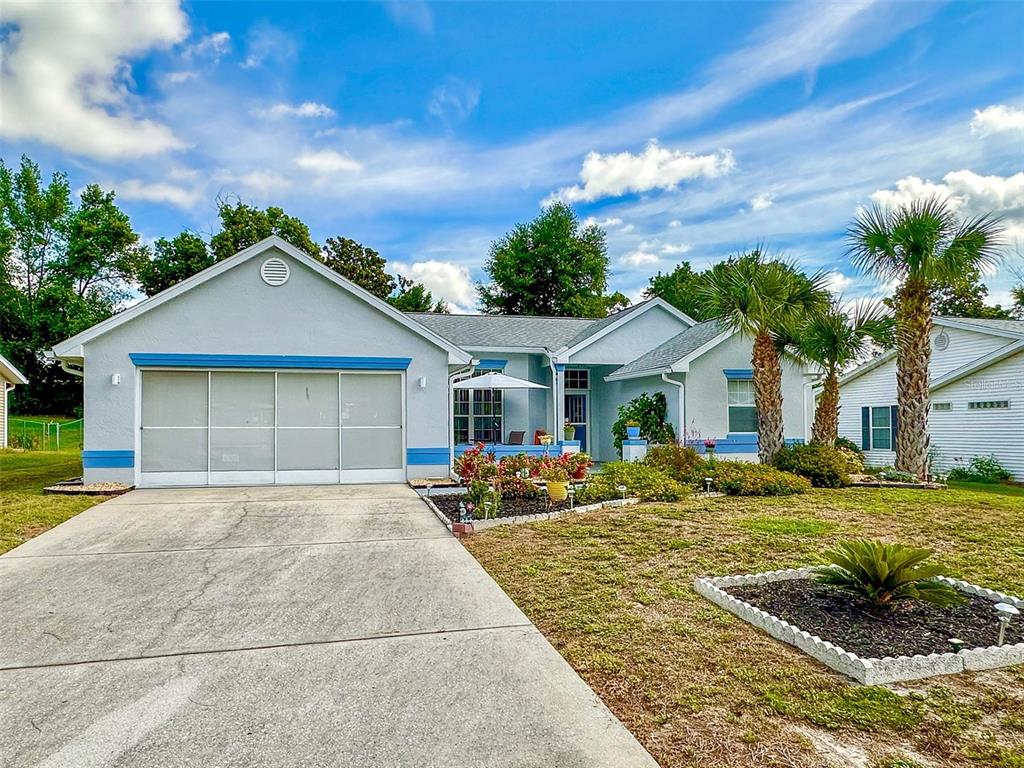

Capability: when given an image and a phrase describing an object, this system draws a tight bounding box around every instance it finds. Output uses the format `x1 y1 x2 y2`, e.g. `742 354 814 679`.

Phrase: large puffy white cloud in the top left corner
0 0 188 159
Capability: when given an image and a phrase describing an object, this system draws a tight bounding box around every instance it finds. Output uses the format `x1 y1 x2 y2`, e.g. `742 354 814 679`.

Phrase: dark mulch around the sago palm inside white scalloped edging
727 579 1024 658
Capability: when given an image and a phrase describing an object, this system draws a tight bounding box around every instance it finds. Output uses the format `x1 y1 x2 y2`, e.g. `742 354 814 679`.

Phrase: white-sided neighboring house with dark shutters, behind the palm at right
839 317 1024 478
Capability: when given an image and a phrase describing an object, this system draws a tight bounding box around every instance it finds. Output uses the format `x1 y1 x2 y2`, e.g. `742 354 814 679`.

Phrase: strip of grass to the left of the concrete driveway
0 451 110 554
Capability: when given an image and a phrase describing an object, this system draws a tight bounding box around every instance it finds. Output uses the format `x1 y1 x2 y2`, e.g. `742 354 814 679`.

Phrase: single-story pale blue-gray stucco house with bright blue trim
53 238 816 486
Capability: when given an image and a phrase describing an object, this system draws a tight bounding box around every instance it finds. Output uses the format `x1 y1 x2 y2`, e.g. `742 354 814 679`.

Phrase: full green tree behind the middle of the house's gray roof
476 203 609 317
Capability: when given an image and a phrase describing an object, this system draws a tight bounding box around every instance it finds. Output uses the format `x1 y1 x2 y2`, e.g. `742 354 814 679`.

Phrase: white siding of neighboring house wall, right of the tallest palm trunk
928 352 1024 479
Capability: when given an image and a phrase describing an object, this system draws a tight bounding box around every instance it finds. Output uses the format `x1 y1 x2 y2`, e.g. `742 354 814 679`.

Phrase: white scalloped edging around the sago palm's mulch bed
693 568 1024 685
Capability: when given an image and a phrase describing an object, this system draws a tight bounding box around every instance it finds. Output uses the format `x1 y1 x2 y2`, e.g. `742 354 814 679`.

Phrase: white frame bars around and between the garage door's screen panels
134 366 409 487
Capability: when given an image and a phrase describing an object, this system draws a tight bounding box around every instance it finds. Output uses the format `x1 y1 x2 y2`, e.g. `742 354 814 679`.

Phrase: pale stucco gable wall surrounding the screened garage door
84 250 451 482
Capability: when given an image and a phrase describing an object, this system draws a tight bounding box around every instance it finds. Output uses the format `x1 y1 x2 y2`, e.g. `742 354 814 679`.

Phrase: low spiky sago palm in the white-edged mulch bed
817 539 964 606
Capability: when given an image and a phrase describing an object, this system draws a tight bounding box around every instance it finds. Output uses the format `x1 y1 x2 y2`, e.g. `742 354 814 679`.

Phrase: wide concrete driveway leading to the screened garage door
0 485 655 768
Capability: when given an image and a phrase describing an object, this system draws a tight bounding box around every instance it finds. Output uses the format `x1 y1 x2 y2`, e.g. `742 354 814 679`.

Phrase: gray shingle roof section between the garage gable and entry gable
409 312 598 350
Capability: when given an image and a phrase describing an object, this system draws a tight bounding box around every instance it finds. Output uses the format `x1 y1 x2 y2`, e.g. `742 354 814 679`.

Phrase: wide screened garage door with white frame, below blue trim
140 371 406 485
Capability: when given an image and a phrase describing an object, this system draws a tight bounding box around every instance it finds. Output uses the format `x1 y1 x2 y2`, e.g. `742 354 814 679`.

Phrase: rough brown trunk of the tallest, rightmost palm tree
896 278 932 480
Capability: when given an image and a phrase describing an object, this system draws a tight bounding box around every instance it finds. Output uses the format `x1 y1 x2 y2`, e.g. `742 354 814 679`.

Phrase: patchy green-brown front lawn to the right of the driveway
465 486 1024 768
